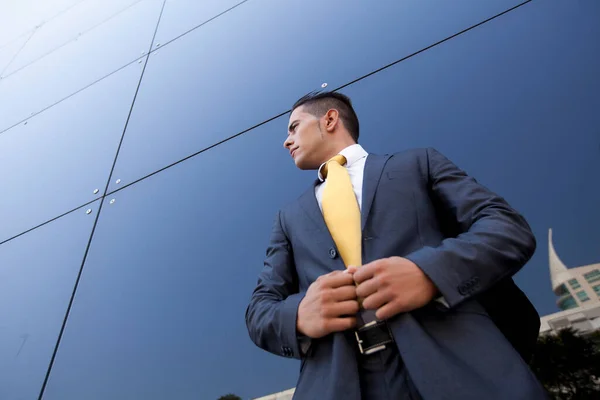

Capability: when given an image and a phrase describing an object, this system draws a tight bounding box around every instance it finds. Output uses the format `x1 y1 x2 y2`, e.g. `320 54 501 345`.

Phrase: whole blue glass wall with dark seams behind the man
0 0 600 400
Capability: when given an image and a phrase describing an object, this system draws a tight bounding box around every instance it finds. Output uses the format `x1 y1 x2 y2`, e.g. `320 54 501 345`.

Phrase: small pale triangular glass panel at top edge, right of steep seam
156 0 244 44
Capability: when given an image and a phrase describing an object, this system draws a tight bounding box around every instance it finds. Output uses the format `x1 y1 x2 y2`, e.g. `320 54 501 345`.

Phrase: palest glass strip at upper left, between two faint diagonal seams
0 0 162 132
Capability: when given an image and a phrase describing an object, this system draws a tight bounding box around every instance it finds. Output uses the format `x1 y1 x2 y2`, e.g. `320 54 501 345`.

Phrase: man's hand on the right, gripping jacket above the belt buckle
348 257 438 320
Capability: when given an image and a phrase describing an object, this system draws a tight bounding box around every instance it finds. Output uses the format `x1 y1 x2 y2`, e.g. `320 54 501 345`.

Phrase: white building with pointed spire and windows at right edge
540 229 600 334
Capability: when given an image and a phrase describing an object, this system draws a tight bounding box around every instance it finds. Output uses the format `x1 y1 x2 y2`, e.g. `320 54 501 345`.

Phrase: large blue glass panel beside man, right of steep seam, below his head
44 118 310 400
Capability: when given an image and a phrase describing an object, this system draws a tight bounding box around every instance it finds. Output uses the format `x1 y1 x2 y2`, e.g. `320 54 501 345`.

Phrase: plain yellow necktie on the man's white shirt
321 155 362 267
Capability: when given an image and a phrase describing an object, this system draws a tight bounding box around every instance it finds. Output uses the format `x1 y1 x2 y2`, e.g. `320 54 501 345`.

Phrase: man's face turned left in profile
283 106 328 170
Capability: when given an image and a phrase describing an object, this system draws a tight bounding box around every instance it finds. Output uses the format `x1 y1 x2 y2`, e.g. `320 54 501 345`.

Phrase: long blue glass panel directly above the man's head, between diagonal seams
109 0 517 189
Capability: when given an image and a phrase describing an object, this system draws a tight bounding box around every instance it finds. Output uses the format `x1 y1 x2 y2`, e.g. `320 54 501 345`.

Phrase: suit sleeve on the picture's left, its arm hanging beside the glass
246 212 304 359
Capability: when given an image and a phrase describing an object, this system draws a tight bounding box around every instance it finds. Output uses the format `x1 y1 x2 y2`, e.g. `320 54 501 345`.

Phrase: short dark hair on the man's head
292 92 359 143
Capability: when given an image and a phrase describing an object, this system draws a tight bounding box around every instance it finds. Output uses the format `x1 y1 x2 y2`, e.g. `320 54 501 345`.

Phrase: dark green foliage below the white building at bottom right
530 328 600 400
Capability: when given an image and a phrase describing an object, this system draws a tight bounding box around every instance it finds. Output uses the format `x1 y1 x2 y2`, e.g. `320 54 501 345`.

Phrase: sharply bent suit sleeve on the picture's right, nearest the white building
406 149 536 307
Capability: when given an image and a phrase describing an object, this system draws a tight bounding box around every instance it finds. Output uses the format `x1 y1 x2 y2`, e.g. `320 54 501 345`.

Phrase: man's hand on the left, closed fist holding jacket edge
296 271 359 339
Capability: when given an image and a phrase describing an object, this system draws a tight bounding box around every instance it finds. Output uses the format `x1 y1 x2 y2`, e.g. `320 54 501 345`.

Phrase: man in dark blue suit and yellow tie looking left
246 93 545 400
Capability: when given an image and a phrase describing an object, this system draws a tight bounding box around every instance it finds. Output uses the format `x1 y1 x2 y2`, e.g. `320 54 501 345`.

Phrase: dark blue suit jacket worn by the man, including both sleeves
246 149 544 400
